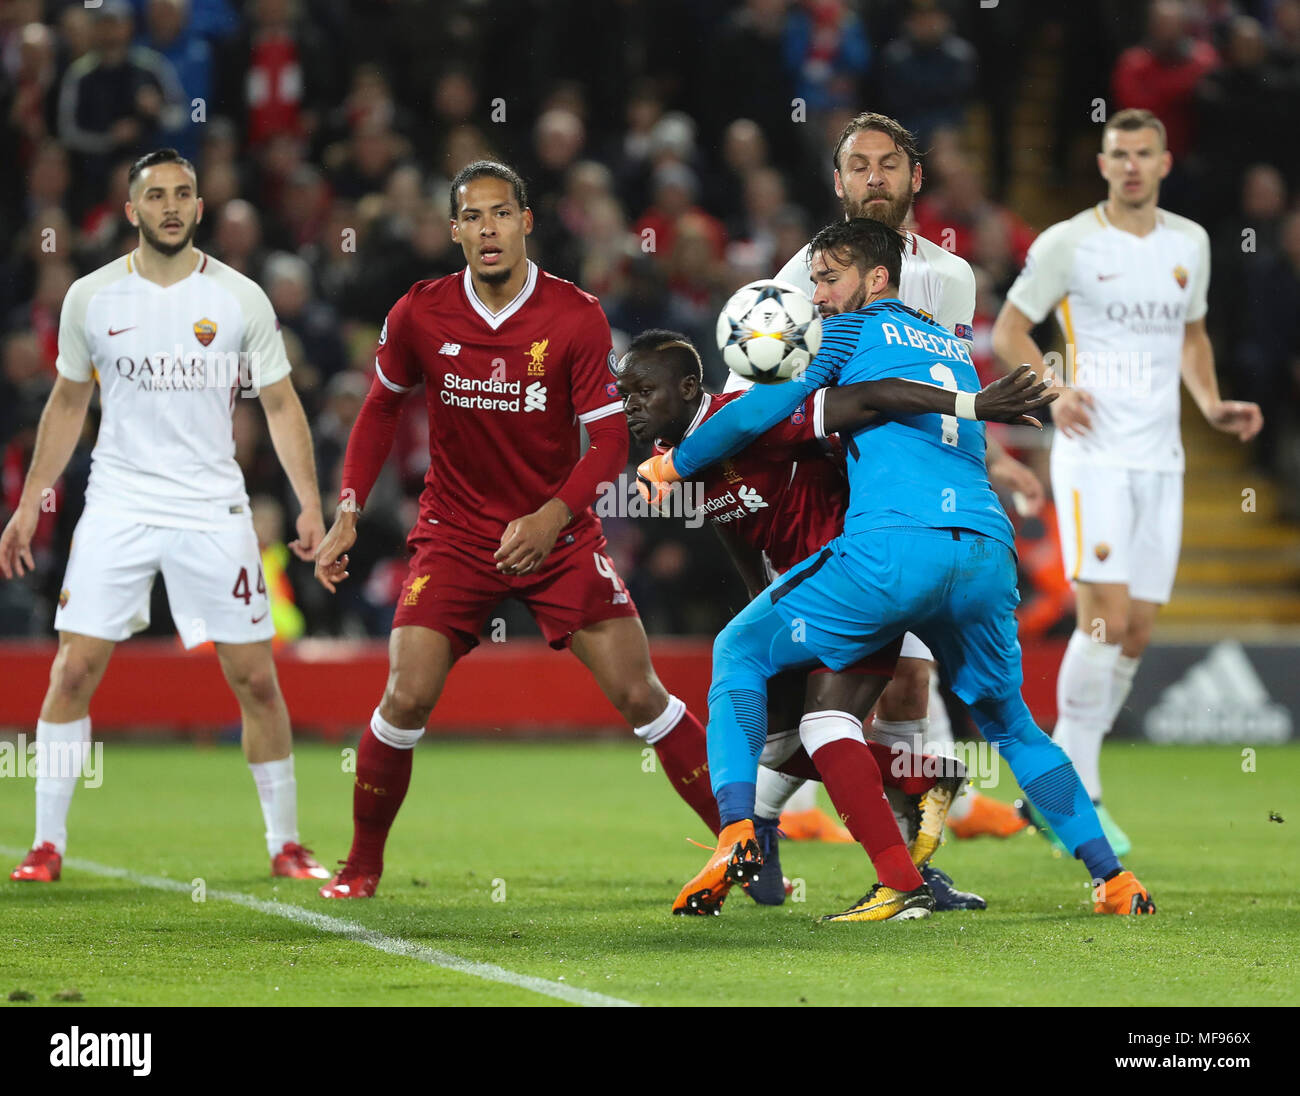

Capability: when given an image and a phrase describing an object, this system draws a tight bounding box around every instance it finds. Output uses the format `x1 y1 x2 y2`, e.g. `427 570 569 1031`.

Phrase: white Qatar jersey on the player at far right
1006 204 1210 472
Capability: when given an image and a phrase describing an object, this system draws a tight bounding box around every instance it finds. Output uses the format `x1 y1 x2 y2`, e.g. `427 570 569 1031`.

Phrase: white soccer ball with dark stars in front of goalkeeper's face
718 280 822 384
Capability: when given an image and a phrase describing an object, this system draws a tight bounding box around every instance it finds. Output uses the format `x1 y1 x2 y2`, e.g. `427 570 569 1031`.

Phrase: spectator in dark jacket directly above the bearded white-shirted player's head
880 0 976 151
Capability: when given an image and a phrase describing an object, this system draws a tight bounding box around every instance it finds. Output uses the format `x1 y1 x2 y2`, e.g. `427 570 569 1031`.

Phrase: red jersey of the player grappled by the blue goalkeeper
665 391 849 573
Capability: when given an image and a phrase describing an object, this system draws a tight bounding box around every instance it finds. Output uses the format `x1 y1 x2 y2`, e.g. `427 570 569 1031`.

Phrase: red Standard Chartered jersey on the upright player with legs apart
374 261 623 550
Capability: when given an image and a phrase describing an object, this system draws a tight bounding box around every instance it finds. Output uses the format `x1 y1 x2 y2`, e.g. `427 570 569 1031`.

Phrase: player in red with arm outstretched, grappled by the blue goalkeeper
619 330 1045 913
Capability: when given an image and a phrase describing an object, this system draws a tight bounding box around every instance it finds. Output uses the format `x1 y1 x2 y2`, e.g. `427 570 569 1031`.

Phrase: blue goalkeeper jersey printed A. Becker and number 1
673 298 1015 547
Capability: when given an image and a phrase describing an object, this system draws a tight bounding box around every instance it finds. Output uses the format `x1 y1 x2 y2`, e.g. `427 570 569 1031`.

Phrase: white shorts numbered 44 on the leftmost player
55 504 276 647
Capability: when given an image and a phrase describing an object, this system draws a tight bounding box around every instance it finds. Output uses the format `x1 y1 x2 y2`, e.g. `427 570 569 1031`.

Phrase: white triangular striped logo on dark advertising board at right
1143 640 1291 742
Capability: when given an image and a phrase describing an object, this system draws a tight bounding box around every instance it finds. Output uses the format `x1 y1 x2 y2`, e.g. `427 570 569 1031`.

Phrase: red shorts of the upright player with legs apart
393 517 638 658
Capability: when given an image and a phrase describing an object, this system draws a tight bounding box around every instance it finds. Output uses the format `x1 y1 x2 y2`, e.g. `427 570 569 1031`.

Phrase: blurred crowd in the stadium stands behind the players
0 0 1300 647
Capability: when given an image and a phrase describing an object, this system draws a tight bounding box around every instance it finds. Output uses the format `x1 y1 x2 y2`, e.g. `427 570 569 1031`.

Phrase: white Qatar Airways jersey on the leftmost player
56 252 289 529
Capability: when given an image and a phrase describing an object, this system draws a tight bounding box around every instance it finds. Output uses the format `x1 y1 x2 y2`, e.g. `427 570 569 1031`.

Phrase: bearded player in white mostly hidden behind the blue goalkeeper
727 113 1043 909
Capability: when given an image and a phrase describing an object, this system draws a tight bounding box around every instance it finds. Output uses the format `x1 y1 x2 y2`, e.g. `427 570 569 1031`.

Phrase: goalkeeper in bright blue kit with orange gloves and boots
640 218 1156 920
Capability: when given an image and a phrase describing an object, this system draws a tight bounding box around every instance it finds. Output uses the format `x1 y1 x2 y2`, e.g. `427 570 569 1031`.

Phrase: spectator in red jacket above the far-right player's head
1112 0 1218 163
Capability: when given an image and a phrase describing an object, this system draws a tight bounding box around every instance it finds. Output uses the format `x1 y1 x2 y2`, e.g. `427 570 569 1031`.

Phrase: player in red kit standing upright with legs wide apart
316 160 718 898
